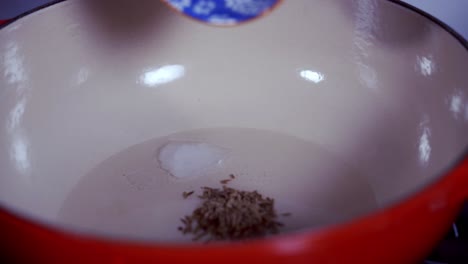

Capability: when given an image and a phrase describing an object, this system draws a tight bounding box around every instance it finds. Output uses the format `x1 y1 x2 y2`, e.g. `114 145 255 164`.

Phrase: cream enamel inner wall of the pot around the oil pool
0 0 468 241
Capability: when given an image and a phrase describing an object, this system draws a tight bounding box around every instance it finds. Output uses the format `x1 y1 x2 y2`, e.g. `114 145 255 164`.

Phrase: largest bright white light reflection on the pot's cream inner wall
138 64 185 87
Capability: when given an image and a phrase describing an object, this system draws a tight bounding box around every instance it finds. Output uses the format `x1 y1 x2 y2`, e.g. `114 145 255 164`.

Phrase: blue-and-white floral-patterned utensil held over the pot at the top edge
164 0 280 25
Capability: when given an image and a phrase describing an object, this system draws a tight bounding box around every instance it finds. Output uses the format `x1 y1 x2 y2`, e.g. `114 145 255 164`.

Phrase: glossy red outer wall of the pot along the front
0 159 468 264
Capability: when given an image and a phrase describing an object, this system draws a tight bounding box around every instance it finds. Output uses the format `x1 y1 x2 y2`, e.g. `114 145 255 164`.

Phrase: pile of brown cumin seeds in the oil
179 177 283 241
